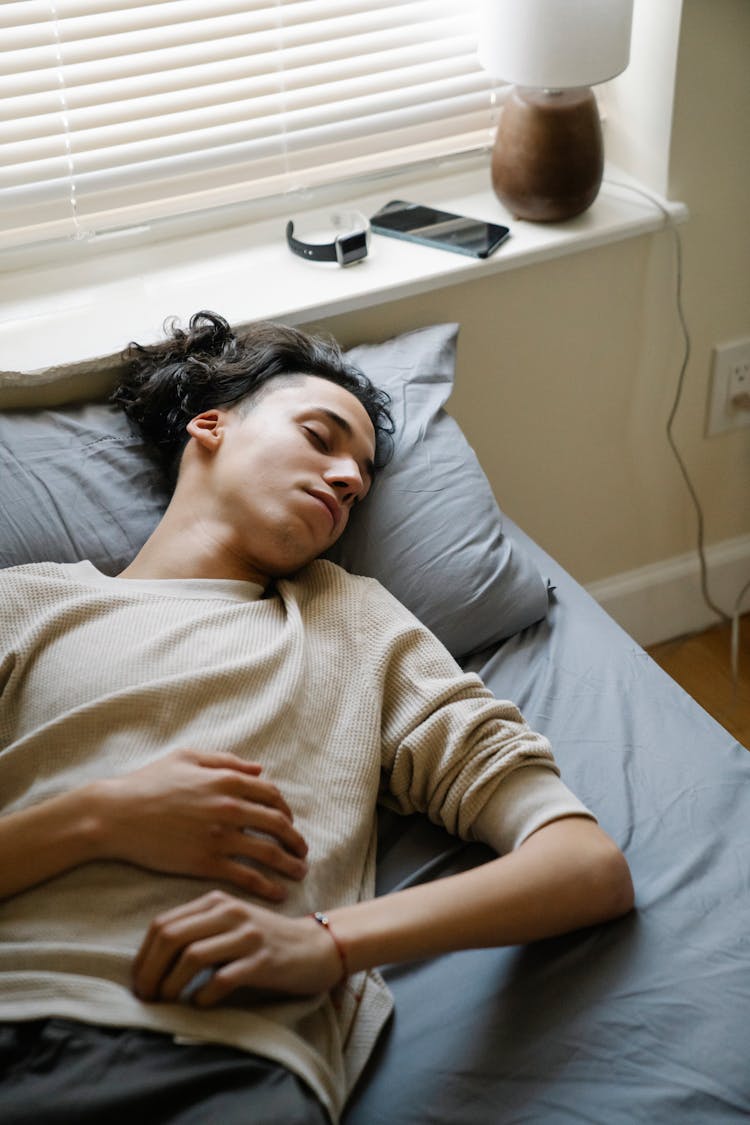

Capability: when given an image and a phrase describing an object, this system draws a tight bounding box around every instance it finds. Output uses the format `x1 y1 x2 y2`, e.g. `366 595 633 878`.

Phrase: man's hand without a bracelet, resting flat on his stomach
96 749 307 902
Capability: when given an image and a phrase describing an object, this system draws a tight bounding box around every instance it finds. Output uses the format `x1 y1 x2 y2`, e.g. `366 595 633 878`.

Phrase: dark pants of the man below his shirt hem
0 1018 329 1125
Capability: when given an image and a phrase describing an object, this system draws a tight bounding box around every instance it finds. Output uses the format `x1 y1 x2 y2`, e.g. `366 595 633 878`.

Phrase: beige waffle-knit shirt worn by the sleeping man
0 561 586 1121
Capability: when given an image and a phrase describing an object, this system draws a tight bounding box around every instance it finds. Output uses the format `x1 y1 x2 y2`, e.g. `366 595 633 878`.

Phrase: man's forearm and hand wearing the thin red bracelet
134 817 633 1007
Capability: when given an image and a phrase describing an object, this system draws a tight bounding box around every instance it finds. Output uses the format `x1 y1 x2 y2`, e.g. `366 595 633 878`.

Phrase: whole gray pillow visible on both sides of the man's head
0 325 548 657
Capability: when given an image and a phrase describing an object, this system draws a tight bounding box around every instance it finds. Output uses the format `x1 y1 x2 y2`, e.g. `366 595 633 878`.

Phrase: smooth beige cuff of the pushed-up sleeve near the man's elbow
471 765 596 855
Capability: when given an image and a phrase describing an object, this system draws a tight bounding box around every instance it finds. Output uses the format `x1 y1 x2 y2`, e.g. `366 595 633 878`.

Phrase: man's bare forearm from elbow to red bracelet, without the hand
328 817 633 972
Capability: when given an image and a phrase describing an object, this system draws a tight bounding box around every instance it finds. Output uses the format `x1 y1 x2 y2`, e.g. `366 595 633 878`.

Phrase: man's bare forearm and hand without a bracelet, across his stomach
0 749 307 902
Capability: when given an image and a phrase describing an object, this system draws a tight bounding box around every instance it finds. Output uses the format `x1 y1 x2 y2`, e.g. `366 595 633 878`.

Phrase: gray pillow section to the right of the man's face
328 324 549 658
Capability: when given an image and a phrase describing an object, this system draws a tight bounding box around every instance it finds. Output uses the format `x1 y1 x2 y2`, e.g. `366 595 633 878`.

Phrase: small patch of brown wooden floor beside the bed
648 613 750 749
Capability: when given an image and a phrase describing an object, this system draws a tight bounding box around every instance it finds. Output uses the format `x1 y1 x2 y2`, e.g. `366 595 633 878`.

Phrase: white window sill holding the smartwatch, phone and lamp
0 160 687 381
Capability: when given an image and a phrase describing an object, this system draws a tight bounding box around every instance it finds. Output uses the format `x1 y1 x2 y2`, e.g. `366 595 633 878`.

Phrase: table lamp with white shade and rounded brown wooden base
479 0 633 223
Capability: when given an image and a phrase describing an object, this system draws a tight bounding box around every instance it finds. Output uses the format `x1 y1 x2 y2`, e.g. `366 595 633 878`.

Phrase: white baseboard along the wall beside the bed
586 536 750 645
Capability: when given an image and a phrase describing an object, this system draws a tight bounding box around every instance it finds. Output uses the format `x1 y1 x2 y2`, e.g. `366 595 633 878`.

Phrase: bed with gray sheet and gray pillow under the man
0 325 750 1125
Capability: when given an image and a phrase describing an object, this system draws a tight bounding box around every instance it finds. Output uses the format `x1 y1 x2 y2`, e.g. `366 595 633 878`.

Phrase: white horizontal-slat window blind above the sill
0 0 495 245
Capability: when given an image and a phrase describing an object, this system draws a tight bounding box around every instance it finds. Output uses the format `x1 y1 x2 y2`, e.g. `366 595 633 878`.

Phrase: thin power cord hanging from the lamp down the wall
605 179 750 695
